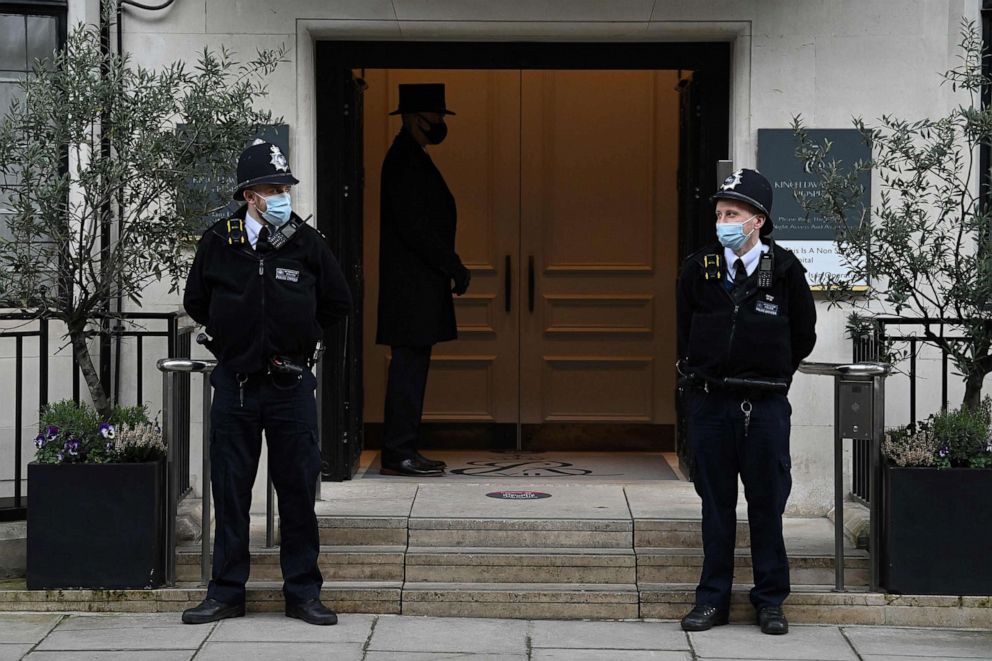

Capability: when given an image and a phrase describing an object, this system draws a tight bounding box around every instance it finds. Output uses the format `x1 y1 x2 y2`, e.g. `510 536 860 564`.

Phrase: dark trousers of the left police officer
207 365 324 604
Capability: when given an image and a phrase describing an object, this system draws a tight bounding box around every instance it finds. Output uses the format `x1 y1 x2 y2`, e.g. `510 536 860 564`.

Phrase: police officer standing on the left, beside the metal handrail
182 140 351 625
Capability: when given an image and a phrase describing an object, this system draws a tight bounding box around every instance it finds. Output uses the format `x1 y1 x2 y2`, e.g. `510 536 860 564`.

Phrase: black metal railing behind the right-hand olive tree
851 317 969 503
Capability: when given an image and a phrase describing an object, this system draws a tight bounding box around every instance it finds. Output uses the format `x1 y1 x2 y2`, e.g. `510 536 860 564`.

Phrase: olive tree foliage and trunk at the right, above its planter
793 21 992 408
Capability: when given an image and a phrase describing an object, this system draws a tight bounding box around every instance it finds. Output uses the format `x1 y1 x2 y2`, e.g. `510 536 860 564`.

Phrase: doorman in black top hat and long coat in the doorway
376 84 471 475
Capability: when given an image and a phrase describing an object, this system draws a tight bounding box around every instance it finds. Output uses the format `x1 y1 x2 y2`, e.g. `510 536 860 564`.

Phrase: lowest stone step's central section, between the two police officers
403 583 639 620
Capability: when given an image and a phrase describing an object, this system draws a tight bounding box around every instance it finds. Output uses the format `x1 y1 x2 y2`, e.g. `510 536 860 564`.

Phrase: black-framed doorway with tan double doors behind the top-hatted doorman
317 44 729 479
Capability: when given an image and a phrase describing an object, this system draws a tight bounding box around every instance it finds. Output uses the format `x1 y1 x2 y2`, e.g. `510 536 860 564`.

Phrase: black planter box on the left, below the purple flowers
27 461 165 590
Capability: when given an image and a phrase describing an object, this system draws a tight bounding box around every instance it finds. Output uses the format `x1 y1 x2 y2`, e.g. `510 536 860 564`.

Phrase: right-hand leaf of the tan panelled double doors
520 71 678 425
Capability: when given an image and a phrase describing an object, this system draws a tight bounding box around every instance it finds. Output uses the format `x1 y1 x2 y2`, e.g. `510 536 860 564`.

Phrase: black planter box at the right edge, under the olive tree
884 466 992 595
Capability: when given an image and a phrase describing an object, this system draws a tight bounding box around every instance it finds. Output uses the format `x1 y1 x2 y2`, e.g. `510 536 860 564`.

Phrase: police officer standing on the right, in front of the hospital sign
677 169 816 634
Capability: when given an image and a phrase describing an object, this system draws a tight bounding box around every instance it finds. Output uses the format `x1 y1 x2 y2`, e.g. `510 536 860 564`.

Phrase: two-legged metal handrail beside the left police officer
156 358 217 585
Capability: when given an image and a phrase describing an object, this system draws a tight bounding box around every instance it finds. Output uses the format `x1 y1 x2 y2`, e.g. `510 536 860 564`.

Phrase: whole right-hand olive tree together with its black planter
793 22 992 594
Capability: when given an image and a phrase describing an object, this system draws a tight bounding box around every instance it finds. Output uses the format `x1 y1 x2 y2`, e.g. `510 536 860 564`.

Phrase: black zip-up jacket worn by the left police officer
183 206 351 374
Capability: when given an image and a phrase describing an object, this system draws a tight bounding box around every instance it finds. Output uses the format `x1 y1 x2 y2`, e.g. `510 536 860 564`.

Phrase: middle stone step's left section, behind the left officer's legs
176 546 406 581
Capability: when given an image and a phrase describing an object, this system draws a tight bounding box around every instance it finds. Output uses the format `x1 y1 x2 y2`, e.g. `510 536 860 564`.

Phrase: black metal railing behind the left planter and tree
0 312 194 521
